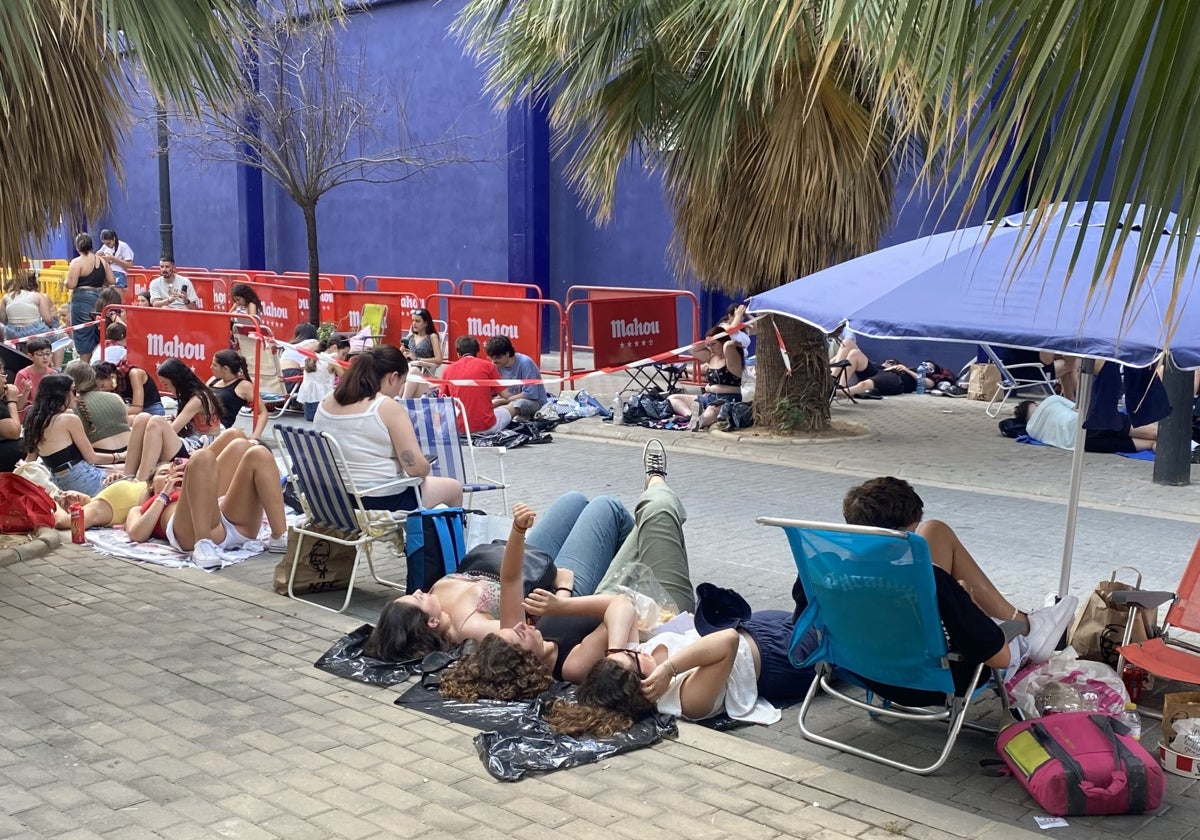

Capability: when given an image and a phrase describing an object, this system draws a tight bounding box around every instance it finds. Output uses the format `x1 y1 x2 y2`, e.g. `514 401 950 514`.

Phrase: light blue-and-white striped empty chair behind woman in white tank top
401 396 509 514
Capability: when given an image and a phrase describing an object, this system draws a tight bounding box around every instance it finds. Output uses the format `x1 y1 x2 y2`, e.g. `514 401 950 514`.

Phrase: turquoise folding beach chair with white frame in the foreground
758 517 1015 775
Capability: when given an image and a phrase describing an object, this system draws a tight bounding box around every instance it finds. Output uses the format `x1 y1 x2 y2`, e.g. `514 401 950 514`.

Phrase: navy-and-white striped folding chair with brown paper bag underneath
275 426 421 612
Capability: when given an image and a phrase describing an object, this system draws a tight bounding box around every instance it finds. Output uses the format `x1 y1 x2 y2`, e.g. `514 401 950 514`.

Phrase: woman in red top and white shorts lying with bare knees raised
125 430 288 553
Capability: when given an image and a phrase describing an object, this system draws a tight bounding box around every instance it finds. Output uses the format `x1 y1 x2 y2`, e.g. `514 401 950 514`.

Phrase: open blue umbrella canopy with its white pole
746 203 1200 594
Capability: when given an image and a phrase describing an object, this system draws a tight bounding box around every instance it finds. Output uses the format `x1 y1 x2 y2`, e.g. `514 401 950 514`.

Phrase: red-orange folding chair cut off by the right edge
1109 541 1200 718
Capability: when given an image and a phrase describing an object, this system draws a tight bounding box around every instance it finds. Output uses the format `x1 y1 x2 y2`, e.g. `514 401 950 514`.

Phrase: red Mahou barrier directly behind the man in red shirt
427 294 566 374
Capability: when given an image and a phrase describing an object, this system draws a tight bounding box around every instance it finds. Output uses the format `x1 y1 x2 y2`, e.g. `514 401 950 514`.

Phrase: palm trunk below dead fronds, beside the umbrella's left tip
754 316 829 434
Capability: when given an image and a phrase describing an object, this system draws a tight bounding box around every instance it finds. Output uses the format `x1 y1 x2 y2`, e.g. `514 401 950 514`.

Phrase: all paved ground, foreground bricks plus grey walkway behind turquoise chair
0 388 1200 840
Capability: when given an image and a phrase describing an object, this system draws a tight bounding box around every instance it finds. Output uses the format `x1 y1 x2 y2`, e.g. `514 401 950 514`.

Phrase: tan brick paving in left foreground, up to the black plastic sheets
0 546 1032 840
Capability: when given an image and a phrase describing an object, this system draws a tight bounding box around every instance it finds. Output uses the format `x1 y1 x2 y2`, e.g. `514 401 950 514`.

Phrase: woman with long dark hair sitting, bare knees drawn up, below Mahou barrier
127 359 221 481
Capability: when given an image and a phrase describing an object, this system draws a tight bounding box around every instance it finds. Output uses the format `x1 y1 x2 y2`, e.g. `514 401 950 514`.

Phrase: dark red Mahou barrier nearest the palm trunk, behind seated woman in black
564 286 701 382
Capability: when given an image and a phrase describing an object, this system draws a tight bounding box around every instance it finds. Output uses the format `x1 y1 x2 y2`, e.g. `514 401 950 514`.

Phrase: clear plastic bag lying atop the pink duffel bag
1007 647 1129 720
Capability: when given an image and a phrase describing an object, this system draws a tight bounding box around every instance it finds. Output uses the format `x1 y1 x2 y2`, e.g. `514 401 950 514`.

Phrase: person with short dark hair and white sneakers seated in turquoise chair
825 475 1078 706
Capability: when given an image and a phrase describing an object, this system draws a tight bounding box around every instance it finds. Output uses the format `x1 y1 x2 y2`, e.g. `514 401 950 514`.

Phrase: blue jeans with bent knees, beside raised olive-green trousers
526 491 634 595
